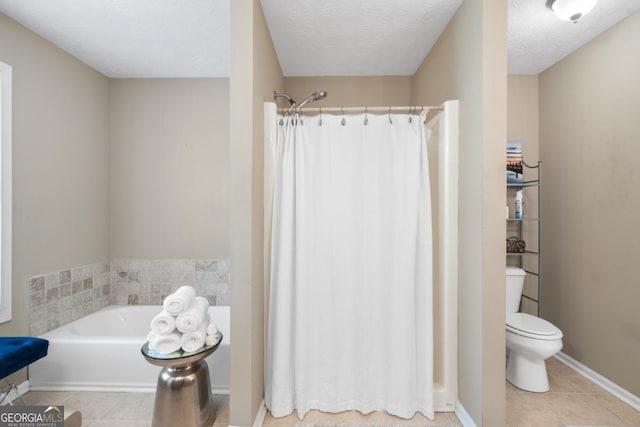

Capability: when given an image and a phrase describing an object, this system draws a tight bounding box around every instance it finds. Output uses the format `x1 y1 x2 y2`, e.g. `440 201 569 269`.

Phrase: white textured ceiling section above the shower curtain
262 0 462 76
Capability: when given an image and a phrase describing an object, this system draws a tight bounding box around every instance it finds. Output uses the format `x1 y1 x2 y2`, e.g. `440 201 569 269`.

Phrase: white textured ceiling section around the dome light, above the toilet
508 0 640 74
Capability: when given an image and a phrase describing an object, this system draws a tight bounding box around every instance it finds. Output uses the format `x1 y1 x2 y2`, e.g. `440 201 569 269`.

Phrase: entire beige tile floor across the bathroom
13 358 640 427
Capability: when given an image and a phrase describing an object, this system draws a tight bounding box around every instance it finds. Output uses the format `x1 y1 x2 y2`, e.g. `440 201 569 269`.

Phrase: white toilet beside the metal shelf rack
506 267 562 392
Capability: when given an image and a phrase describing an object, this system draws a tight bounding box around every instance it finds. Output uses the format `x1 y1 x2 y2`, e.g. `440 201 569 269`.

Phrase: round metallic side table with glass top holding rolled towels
140 332 222 427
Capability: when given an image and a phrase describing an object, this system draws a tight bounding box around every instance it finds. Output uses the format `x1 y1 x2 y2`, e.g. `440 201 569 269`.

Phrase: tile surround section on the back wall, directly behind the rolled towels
111 259 229 305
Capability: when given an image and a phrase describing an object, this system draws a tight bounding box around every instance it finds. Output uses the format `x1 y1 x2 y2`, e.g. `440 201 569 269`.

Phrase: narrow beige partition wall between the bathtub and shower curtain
229 0 284 426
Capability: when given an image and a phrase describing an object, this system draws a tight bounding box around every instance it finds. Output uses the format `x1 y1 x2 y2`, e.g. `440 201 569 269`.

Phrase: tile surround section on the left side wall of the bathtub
29 261 111 335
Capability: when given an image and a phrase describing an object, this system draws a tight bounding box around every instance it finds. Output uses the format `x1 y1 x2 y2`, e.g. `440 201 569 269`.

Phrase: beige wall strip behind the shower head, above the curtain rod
278 76 411 107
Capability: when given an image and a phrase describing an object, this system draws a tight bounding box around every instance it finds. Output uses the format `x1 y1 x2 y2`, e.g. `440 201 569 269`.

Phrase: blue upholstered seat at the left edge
0 337 49 379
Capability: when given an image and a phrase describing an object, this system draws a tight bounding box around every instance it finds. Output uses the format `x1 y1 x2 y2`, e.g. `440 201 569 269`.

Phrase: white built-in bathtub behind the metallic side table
29 305 231 394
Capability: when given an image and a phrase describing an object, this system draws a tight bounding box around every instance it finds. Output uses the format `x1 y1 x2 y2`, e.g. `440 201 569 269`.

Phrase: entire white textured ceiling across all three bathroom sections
0 0 640 78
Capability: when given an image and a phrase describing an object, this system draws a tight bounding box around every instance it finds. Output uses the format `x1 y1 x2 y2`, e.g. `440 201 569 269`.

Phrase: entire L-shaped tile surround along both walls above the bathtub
28 259 229 335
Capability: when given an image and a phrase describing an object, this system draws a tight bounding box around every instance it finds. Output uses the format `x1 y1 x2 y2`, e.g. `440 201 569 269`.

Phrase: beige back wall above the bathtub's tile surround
105 79 229 259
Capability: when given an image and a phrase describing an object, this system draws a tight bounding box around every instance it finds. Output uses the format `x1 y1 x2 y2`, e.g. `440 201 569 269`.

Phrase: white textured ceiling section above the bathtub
0 0 229 77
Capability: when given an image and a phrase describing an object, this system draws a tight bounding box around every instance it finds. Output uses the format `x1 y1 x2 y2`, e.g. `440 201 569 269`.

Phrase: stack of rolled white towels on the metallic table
147 286 220 354
